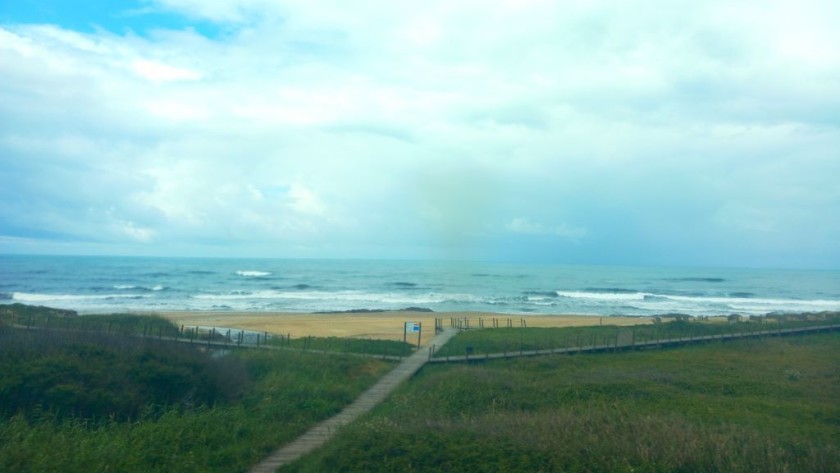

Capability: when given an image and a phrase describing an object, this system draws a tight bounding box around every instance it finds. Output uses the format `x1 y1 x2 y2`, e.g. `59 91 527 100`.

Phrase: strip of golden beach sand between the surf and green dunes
159 311 653 345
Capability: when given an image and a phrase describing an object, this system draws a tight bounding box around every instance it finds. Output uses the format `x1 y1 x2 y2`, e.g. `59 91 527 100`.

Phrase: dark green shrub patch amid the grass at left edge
0 329 250 420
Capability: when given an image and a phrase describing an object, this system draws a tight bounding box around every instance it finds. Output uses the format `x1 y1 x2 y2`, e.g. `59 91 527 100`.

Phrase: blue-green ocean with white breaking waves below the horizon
0 255 840 316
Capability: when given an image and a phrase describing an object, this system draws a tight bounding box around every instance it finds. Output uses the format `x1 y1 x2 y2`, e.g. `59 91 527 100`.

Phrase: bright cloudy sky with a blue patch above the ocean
0 0 840 269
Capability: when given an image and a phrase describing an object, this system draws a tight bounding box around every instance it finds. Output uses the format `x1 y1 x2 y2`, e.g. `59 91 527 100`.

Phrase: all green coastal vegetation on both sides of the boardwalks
0 305 840 472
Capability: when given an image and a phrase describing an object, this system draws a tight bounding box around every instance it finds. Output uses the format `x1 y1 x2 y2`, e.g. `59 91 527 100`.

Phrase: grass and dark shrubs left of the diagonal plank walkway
0 307 393 472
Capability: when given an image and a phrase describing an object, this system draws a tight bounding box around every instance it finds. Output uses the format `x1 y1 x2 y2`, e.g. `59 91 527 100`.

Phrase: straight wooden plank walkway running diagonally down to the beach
250 329 457 473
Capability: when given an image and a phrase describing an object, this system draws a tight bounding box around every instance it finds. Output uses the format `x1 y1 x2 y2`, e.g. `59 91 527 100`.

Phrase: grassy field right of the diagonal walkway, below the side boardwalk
283 332 840 472
